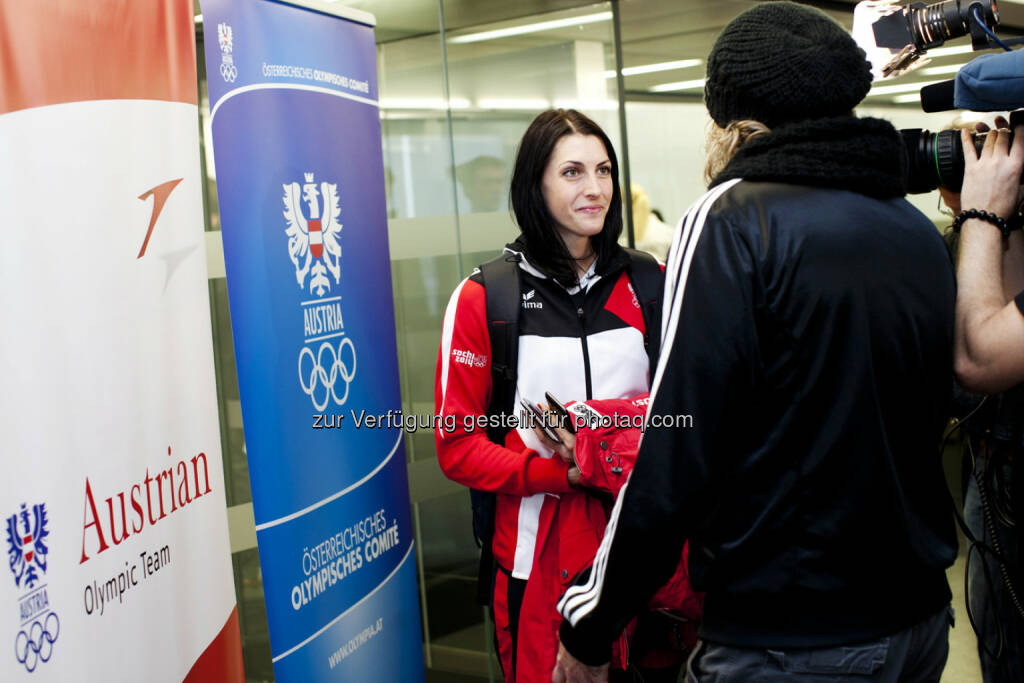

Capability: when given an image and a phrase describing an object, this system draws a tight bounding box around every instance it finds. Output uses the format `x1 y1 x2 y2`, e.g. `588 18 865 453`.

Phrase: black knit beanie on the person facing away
705 2 871 128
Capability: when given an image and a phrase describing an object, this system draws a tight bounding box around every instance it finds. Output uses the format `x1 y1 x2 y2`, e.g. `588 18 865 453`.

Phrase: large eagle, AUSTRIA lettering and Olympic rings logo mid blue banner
284 173 355 411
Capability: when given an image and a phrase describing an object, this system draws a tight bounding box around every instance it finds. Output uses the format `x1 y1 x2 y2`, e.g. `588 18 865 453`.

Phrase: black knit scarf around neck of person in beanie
711 117 906 199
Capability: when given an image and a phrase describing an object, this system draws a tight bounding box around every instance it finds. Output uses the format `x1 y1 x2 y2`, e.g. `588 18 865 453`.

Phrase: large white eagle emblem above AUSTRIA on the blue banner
284 173 341 297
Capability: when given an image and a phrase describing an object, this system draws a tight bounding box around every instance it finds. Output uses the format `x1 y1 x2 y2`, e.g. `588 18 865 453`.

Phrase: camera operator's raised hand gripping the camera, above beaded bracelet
961 122 1024 218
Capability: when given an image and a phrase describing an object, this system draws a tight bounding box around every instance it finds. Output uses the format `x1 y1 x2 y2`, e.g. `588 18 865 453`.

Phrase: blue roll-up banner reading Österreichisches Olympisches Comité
202 0 424 681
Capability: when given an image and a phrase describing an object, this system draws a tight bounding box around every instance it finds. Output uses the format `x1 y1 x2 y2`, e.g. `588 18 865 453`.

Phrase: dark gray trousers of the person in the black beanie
686 606 952 683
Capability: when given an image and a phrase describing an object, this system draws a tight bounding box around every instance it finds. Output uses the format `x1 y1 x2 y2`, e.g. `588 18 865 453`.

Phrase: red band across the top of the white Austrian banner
0 0 199 114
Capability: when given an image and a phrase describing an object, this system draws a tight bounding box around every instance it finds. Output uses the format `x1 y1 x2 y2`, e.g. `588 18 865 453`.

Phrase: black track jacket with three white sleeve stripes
559 179 956 665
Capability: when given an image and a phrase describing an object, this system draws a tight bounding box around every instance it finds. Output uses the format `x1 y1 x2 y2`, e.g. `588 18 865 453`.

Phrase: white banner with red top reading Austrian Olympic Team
0 0 242 681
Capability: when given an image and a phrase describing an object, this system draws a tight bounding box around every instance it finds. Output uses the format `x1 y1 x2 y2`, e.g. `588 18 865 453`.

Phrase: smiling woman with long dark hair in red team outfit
435 110 678 682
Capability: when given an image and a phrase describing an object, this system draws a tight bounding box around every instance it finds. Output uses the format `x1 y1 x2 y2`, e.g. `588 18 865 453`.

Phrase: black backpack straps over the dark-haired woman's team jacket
469 249 665 606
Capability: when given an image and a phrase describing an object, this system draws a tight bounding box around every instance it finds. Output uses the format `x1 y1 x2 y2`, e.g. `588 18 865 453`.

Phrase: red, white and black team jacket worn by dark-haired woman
435 244 649 580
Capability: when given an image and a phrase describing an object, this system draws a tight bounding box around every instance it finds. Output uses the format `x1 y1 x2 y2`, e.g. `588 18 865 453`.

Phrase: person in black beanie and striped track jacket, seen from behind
552 2 956 683
